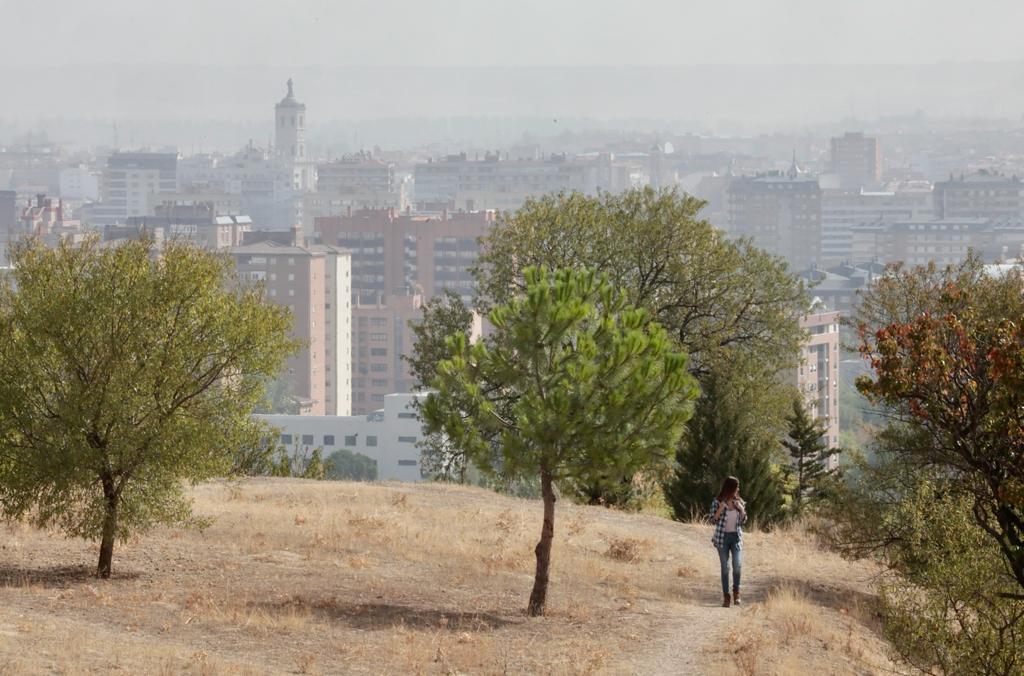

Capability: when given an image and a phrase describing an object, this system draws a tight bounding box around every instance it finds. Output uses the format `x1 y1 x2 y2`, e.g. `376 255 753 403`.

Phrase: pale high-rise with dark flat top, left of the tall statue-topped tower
92 153 178 225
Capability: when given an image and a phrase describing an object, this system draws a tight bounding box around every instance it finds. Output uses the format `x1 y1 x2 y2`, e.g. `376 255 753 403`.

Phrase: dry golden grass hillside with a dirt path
0 479 891 674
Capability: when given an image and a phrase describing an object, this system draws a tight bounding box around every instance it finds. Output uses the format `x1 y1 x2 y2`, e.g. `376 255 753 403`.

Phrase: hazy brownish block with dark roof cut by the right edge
934 169 1024 218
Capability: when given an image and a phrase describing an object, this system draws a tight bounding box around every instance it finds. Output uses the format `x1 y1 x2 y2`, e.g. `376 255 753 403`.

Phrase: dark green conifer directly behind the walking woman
665 368 785 526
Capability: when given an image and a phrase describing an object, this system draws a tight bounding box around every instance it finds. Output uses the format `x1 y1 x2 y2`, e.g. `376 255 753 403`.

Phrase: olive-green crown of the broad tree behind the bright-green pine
477 187 808 376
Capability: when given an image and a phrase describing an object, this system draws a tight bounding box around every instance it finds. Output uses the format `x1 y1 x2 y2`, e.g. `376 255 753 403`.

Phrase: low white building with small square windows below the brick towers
256 394 432 481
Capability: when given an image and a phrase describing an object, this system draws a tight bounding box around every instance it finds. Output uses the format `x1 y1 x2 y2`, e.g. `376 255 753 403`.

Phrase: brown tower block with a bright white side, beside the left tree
231 241 352 416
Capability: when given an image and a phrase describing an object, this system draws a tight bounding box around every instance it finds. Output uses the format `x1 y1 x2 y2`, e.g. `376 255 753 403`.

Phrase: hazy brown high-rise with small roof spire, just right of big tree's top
726 160 821 269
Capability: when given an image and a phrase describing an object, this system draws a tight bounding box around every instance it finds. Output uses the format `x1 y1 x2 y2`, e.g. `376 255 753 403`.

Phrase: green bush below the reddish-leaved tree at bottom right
827 446 1024 676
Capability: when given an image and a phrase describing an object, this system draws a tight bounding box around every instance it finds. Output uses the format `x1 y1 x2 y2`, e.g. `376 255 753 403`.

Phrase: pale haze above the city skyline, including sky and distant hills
0 0 1024 150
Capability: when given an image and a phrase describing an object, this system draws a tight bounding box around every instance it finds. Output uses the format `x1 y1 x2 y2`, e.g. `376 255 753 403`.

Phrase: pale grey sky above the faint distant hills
6 0 1024 67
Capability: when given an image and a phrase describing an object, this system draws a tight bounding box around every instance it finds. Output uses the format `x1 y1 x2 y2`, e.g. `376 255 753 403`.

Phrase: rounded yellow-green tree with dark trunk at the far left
0 239 296 577
